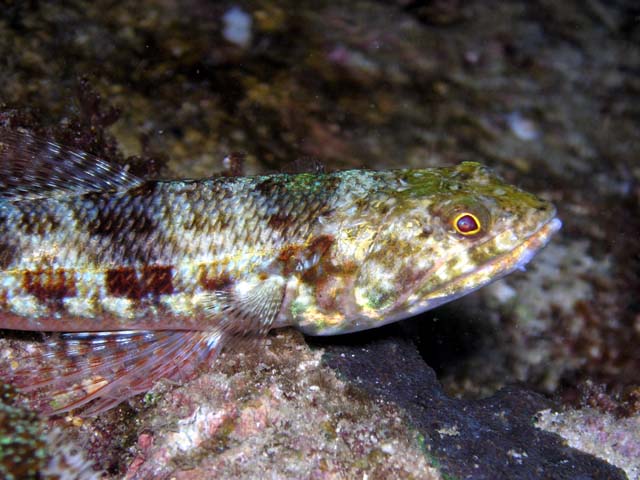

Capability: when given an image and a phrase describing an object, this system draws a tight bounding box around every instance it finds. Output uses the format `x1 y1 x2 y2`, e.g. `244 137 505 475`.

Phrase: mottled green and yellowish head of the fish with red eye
353 162 561 329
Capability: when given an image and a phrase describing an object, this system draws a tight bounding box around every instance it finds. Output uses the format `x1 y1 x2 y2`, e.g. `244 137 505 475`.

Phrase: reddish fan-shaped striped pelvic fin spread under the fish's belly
6 330 222 415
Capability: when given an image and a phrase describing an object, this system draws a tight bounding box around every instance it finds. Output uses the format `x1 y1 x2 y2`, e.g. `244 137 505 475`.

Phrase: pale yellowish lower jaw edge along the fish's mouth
394 217 562 320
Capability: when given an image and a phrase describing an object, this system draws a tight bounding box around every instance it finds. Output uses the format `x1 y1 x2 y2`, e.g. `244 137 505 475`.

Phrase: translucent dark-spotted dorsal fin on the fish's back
0 129 142 199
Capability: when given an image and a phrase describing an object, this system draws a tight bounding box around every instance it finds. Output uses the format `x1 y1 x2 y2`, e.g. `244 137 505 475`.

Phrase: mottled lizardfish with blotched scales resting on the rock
0 129 562 415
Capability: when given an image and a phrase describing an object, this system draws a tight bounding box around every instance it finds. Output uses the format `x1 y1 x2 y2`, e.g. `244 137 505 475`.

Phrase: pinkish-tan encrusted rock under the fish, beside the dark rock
120 332 440 479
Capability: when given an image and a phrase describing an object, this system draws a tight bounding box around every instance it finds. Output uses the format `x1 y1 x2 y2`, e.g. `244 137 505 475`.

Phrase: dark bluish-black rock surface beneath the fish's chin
318 329 625 479
